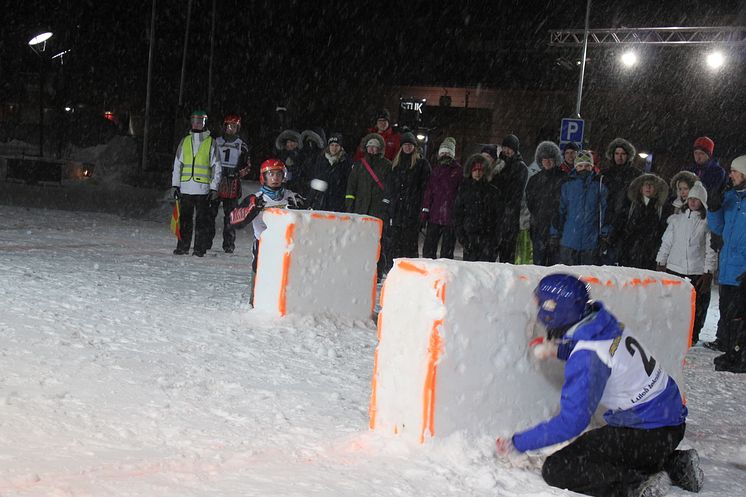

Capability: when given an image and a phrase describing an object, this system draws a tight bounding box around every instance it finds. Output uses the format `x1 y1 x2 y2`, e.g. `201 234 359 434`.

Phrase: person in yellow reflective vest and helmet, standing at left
171 110 221 257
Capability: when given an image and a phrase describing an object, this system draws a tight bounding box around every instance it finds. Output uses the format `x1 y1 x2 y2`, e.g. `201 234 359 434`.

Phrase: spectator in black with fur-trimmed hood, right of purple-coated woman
453 153 497 262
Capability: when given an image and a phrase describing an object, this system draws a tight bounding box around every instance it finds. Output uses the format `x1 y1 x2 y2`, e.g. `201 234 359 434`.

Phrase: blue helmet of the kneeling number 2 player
534 273 590 336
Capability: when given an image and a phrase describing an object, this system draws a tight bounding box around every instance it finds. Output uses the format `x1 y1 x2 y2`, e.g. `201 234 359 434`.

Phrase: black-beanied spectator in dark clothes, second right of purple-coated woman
490 134 528 264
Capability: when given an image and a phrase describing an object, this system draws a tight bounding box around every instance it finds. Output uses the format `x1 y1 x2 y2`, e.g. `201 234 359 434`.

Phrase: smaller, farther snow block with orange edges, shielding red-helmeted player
254 209 383 319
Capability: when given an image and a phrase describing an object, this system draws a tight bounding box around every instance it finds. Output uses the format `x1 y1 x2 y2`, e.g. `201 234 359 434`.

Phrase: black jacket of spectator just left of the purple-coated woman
383 153 431 227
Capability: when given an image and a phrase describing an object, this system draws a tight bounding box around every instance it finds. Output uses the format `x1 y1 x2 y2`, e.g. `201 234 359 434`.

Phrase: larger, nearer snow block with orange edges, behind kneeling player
369 259 695 443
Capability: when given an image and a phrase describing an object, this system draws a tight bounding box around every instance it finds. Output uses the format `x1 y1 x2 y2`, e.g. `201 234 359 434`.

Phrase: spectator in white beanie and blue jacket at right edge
707 155 746 362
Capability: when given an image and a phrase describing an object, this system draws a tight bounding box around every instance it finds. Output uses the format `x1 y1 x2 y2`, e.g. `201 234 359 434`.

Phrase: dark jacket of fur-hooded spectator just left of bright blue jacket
526 165 567 238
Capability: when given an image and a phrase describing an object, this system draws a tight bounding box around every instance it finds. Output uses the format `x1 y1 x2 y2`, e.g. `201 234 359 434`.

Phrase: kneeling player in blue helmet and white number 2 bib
497 274 704 497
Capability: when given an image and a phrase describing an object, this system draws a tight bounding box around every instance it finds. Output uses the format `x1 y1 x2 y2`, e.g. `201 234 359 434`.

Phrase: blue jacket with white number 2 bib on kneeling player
513 302 687 452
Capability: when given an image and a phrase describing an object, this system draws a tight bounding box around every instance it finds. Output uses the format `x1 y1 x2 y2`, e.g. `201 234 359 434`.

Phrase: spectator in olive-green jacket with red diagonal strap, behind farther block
345 133 398 279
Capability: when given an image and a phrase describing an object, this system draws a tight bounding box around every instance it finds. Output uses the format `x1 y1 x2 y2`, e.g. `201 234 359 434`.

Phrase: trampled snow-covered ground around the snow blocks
0 206 746 497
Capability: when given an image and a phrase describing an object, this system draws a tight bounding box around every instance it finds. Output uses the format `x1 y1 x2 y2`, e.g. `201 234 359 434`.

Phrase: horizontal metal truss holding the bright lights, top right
549 26 746 47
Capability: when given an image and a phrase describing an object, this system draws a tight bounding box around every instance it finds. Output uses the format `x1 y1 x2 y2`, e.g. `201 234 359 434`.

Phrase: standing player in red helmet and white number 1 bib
209 114 251 254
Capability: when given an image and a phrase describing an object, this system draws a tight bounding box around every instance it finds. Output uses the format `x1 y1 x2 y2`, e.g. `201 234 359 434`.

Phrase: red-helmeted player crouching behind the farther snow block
231 159 304 305
